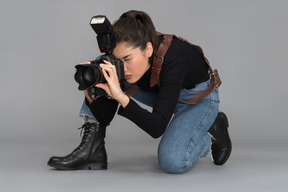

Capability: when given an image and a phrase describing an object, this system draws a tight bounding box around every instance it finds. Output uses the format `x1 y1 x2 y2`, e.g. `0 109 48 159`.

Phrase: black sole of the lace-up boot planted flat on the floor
48 162 108 170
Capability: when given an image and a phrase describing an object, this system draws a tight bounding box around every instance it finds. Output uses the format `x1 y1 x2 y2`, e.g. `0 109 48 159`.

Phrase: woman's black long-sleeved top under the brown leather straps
118 38 208 138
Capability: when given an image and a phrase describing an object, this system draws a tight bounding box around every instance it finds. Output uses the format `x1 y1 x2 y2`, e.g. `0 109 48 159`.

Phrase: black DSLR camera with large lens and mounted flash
74 15 125 96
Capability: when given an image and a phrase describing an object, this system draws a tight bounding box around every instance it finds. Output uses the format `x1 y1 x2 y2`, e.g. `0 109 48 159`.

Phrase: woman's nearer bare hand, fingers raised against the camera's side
95 60 130 107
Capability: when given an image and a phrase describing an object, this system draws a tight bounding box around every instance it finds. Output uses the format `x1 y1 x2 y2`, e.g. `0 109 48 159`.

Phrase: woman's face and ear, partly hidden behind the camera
113 42 153 83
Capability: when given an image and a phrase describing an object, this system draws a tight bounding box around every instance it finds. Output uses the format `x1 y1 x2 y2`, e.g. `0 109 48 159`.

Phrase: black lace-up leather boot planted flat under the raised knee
48 122 107 170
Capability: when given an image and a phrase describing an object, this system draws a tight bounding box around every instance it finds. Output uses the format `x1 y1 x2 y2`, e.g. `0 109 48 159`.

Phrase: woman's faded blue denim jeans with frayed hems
80 80 219 173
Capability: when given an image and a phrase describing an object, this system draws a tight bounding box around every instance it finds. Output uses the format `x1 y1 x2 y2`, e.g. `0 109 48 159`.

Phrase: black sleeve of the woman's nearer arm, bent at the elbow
118 48 185 138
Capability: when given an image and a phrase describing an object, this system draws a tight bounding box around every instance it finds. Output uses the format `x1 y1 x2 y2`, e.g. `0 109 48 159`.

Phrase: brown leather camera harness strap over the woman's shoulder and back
126 32 222 104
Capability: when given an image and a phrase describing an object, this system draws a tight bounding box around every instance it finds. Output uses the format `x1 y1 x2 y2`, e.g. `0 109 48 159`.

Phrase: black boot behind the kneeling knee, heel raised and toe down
208 112 232 165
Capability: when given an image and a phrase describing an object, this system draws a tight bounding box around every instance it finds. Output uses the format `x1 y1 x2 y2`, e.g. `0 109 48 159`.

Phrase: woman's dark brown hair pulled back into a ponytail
113 10 158 52
